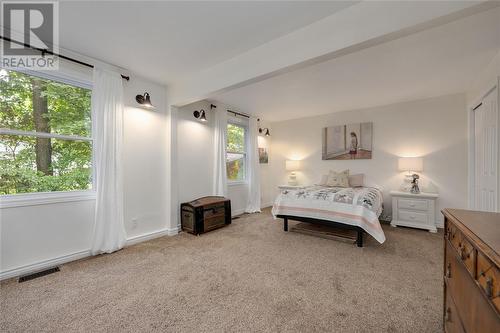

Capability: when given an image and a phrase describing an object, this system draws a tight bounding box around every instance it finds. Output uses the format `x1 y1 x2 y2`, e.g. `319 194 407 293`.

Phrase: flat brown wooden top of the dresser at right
443 209 500 264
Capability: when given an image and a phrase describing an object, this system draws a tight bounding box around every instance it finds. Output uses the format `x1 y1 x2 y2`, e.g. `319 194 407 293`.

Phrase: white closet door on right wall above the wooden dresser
474 89 499 212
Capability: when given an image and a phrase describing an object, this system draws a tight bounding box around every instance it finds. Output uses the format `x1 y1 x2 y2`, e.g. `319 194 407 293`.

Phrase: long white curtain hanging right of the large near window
91 68 126 255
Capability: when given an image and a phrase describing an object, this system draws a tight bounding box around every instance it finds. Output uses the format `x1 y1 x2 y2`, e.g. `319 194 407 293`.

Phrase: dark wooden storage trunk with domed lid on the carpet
181 196 231 235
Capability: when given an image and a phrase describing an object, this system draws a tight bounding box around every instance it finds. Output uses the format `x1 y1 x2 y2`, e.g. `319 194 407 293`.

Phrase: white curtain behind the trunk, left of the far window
213 108 227 197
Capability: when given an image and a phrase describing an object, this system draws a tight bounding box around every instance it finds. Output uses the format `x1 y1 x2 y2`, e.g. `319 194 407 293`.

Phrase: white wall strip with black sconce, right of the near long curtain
123 75 170 238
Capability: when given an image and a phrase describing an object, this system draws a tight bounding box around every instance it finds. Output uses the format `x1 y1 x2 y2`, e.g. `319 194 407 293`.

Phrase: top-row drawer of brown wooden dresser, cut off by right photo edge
477 253 500 313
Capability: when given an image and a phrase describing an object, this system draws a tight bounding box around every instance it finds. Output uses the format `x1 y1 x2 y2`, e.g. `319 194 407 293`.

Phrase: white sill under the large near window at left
0 191 96 208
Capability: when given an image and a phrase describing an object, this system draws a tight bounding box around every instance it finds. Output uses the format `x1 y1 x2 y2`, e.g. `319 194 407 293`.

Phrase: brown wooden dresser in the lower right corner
443 209 500 333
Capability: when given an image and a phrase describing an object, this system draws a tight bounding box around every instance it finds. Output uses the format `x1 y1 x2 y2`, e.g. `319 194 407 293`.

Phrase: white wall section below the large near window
0 200 94 278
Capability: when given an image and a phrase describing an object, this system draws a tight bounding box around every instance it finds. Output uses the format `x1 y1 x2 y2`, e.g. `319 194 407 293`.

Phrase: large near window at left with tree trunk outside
0 69 92 195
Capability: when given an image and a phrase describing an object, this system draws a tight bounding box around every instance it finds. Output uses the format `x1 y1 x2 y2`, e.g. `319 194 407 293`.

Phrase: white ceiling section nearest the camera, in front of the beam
59 1 355 84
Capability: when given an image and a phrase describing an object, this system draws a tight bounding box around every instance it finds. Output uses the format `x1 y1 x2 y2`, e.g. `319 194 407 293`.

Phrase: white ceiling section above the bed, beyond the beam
213 8 500 121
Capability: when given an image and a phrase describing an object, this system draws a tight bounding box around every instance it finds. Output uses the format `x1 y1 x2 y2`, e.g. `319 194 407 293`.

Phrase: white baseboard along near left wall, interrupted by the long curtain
0 227 179 281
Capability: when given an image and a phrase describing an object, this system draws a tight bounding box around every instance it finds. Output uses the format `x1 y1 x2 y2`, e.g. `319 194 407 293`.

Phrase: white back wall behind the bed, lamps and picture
265 94 467 221
